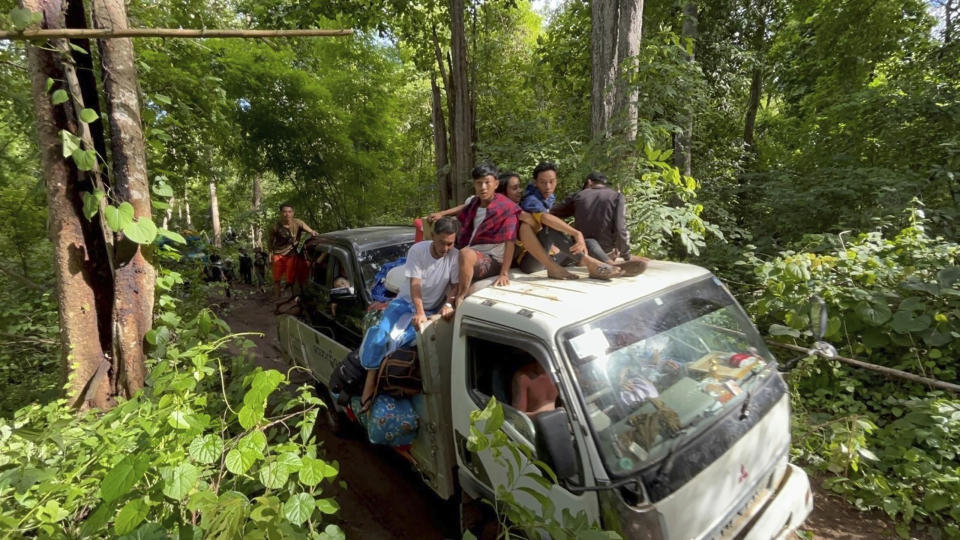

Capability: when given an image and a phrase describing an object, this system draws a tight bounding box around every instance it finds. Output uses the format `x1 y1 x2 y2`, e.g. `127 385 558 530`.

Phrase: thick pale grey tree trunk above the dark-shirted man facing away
590 0 643 141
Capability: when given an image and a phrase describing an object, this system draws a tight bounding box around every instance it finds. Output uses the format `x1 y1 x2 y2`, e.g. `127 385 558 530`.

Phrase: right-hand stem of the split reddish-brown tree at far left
92 0 157 397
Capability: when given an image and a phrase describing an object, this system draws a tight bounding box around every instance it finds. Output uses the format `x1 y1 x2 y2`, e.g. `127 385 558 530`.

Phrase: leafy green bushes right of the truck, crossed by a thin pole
740 204 960 536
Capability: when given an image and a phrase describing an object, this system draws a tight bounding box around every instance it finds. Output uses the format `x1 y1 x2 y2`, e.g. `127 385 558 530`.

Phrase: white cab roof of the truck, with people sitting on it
463 261 710 330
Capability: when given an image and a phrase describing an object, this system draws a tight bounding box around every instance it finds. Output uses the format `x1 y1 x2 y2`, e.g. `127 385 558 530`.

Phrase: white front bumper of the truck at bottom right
736 463 813 540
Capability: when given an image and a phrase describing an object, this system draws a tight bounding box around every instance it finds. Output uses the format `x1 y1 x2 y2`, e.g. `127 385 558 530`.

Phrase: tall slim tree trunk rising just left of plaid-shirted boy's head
450 0 473 201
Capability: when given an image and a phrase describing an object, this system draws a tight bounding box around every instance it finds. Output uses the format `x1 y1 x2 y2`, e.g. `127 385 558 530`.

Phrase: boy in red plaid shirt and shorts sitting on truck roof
456 165 520 306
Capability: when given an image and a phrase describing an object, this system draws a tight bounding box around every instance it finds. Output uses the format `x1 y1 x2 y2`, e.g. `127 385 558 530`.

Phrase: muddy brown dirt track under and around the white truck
221 287 897 540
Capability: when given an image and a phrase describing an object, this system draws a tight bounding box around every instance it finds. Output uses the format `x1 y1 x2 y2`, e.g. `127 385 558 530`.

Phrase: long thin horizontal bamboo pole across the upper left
0 28 353 41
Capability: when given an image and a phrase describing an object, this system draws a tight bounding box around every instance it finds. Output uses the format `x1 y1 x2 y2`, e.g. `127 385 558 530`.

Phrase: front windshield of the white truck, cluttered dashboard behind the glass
561 277 774 476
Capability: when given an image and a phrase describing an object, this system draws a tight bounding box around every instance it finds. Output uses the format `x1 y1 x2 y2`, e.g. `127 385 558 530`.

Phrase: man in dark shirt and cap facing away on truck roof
550 172 646 273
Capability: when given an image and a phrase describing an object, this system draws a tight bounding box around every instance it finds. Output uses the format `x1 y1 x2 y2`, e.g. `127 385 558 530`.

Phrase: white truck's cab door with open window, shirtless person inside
451 326 599 523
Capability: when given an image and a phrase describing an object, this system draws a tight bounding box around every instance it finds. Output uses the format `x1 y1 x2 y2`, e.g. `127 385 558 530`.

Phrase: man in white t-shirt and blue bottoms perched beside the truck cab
360 217 460 408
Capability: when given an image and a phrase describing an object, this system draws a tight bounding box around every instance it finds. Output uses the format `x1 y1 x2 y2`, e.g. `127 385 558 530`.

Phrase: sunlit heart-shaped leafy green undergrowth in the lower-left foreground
0 262 343 539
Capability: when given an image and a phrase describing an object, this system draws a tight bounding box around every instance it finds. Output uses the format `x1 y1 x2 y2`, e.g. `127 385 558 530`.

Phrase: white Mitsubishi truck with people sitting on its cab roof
279 229 813 540
